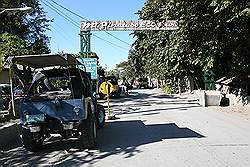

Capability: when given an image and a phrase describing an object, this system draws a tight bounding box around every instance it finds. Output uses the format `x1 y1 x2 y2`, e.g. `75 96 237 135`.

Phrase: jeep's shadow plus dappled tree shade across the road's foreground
0 120 204 166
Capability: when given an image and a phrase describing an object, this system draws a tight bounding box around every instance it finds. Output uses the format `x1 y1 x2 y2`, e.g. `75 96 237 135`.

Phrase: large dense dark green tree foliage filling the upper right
131 0 250 87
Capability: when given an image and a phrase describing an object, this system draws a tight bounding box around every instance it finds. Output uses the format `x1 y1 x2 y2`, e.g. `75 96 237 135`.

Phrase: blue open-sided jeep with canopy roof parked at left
8 54 105 151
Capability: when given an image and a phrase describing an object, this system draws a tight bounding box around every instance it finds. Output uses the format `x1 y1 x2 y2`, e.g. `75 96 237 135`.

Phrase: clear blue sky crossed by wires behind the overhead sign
40 0 146 70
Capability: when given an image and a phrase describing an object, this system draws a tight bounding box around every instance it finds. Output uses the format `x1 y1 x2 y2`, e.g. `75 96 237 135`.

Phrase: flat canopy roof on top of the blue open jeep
7 54 82 68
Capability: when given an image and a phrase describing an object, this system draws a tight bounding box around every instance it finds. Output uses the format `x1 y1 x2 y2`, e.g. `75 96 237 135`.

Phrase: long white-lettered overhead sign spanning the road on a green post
81 20 178 31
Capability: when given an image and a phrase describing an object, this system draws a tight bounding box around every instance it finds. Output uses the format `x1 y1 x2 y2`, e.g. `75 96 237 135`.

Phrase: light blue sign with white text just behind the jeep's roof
79 58 97 79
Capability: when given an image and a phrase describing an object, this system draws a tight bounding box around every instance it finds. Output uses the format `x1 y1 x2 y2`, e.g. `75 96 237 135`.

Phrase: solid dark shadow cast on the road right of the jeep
96 120 204 152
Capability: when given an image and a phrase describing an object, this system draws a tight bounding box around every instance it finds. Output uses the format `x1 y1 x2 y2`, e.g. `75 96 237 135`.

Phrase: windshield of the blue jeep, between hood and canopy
27 68 87 100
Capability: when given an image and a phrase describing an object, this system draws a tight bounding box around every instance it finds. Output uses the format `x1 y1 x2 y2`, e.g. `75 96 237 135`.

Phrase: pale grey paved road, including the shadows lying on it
0 90 250 167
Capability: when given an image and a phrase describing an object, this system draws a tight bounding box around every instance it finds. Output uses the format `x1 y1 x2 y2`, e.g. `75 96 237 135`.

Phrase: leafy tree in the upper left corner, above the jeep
0 0 51 67
